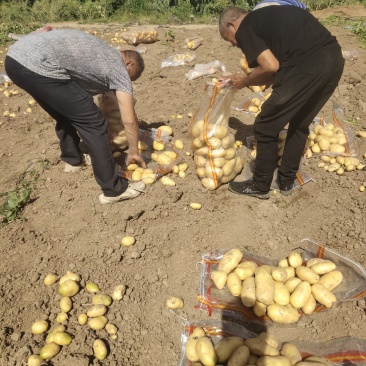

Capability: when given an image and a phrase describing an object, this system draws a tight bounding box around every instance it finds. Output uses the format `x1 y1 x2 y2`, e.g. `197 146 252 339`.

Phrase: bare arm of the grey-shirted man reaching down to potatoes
116 91 146 168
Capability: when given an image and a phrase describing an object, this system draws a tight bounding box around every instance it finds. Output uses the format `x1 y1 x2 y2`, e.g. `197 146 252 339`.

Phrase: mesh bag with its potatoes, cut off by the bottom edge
178 320 366 366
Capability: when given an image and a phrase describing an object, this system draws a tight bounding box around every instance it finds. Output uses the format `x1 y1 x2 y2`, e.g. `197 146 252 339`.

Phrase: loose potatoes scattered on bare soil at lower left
28 271 126 366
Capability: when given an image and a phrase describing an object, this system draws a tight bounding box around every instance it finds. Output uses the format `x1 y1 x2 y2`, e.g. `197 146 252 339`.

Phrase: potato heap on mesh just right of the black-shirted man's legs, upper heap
306 123 349 158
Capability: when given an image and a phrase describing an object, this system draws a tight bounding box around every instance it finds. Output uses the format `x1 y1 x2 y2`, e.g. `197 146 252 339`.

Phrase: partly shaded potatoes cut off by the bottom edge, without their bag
185 327 333 366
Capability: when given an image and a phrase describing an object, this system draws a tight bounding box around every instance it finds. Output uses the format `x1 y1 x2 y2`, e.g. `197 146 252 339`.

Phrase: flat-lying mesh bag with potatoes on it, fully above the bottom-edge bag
198 239 366 325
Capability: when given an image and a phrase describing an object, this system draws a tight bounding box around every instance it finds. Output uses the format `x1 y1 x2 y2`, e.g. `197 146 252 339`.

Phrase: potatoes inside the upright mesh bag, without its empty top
191 120 244 190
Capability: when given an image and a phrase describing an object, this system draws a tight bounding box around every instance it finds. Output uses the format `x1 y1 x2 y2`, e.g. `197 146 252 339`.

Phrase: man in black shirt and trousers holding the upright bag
219 6 344 199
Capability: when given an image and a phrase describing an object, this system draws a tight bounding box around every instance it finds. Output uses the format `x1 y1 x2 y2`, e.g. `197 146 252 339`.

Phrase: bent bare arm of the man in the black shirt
231 50 280 89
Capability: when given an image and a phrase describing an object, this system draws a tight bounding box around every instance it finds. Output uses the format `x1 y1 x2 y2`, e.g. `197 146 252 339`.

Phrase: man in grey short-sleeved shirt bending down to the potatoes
5 30 145 204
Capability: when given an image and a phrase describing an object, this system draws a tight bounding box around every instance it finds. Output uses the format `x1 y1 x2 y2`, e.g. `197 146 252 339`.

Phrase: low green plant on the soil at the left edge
0 160 49 223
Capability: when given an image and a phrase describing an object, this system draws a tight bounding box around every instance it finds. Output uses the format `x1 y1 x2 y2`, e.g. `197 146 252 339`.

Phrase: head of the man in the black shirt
219 6 248 47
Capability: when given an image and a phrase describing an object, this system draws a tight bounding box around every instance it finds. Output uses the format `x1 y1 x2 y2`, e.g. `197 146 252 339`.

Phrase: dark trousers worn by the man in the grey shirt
5 56 127 197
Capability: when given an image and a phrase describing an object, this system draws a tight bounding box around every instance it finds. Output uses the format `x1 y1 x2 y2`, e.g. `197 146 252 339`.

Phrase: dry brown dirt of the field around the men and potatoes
0 7 366 366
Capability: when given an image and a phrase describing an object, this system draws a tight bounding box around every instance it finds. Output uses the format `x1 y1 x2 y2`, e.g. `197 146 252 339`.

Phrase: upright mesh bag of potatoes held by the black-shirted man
190 82 244 190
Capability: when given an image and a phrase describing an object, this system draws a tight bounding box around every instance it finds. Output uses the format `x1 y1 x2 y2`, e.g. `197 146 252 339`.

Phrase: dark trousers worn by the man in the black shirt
254 44 344 191
